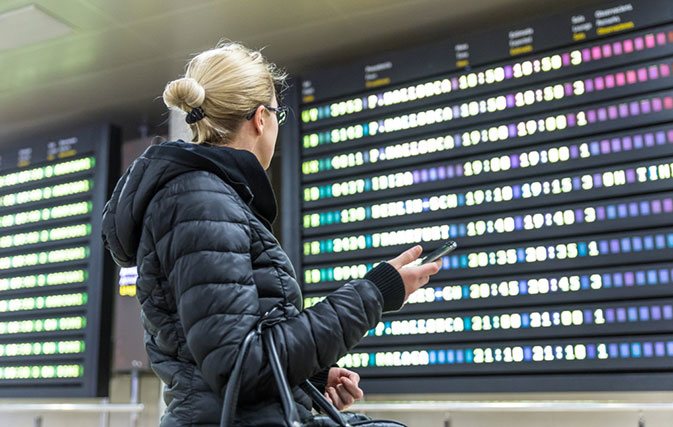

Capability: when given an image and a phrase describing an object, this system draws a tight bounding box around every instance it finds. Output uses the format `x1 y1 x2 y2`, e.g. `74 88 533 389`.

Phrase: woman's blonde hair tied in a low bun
163 42 287 144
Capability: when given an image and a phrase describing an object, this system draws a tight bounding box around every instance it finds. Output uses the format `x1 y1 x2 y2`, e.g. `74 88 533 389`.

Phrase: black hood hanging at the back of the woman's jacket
102 141 275 267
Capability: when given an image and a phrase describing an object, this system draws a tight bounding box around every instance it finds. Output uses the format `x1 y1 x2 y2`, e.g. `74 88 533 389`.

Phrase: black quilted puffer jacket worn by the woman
103 141 404 426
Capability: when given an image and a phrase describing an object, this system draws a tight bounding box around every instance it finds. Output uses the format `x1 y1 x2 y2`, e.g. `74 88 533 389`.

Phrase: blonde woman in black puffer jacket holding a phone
103 43 439 426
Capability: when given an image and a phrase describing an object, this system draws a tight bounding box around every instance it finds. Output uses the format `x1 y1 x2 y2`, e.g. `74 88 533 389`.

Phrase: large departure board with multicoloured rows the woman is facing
285 0 673 393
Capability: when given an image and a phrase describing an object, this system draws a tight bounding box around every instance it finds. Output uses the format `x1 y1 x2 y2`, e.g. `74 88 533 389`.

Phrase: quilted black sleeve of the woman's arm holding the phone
149 173 399 403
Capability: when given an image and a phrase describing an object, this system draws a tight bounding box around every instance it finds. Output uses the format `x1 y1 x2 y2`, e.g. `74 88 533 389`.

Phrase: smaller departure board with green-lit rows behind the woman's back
0 126 119 397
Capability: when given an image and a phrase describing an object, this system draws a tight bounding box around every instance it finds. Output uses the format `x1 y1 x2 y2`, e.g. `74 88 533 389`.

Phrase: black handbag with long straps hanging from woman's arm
220 310 405 427
